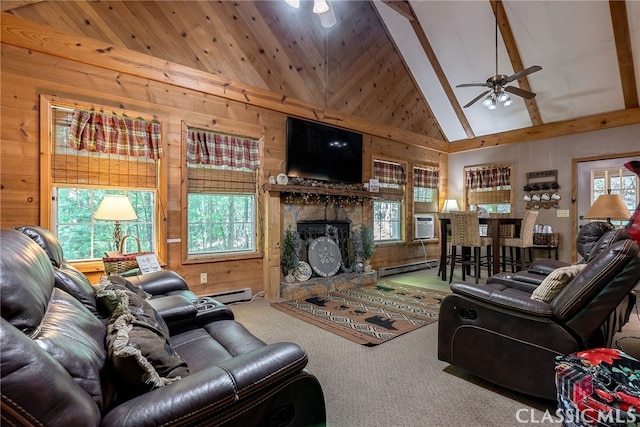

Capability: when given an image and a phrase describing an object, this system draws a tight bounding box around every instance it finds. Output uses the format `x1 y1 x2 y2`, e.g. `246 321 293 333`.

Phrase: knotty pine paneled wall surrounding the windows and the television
0 43 448 297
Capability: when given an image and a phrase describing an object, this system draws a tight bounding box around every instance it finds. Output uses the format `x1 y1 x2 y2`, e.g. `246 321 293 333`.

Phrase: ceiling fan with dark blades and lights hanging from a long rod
456 1 542 110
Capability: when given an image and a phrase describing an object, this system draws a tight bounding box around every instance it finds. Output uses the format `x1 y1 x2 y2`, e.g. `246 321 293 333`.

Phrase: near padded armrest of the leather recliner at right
451 282 553 317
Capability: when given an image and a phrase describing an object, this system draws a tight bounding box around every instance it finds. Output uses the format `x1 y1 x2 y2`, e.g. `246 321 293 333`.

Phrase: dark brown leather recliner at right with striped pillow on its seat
438 234 640 399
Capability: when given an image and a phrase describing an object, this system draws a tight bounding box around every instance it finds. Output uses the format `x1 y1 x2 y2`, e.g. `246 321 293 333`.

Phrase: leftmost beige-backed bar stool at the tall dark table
449 211 493 283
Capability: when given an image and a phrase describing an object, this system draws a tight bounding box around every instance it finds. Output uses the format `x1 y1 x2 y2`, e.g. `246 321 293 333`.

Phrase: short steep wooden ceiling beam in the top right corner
609 0 638 108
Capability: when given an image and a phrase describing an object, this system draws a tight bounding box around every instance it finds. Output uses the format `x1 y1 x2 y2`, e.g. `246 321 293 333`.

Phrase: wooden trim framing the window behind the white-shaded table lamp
40 95 167 273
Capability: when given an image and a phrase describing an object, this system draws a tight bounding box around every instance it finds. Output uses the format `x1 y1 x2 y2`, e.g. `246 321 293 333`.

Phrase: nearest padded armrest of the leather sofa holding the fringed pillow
102 343 307 426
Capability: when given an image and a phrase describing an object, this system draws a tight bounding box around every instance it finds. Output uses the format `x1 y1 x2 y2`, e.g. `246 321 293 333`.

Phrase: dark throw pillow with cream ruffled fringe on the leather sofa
97 283 189 388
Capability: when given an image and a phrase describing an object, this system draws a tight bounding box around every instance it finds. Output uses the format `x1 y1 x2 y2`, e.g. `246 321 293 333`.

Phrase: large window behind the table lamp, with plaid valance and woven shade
43 103 162 261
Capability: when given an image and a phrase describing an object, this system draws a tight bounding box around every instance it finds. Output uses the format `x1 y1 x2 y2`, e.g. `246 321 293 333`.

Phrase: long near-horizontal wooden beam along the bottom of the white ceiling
449 107 640 153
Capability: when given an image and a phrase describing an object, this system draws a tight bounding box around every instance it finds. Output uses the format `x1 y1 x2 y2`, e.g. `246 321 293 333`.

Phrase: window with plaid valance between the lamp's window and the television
186 128 260 255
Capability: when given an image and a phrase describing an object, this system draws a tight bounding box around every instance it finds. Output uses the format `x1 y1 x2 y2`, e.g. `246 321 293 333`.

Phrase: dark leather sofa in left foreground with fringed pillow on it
0 229 326 426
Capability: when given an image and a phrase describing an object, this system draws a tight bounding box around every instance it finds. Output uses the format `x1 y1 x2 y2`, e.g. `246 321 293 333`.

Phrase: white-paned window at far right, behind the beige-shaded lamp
591 167 640 227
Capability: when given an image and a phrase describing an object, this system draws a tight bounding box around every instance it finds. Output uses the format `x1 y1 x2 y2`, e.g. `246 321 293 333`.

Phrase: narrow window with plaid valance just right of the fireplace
373 160 407 242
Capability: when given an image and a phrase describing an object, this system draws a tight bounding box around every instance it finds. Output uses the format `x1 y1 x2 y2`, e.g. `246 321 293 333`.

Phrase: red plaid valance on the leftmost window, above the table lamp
69 110 163 160
